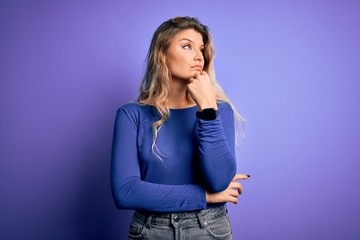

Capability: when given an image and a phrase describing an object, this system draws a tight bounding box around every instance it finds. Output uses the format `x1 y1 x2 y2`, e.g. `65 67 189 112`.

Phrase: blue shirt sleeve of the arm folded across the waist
111 108 206 212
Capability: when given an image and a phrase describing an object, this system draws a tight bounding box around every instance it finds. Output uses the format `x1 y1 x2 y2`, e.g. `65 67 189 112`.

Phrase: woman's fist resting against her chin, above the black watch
187 71 217 111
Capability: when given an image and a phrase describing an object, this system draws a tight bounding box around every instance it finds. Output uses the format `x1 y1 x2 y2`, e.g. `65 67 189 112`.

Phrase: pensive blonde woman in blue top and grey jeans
111 17 249 239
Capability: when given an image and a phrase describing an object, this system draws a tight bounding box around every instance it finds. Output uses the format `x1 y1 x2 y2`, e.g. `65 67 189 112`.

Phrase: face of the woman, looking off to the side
166 29 204 81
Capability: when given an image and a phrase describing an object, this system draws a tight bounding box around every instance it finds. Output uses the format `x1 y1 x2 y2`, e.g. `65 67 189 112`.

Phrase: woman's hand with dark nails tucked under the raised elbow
206 174 250 204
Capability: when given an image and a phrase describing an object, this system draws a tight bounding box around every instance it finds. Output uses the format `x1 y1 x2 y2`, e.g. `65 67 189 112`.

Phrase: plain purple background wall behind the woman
0 0 360 240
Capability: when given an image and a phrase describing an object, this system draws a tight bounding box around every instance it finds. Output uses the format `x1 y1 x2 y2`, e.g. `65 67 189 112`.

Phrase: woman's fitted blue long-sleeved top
111 103 236 212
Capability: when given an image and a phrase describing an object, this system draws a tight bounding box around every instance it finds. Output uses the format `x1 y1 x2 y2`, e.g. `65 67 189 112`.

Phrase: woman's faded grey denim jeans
128 205 232 240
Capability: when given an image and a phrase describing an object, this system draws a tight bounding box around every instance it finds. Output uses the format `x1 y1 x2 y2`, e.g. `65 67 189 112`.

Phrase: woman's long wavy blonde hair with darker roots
138 17 245 156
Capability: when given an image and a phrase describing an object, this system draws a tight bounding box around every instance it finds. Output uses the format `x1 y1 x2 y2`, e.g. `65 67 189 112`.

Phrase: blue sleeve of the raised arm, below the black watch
198 104 236 192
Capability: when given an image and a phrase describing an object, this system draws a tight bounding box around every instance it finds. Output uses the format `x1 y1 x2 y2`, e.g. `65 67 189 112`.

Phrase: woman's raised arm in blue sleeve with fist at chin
187 71 236 192
